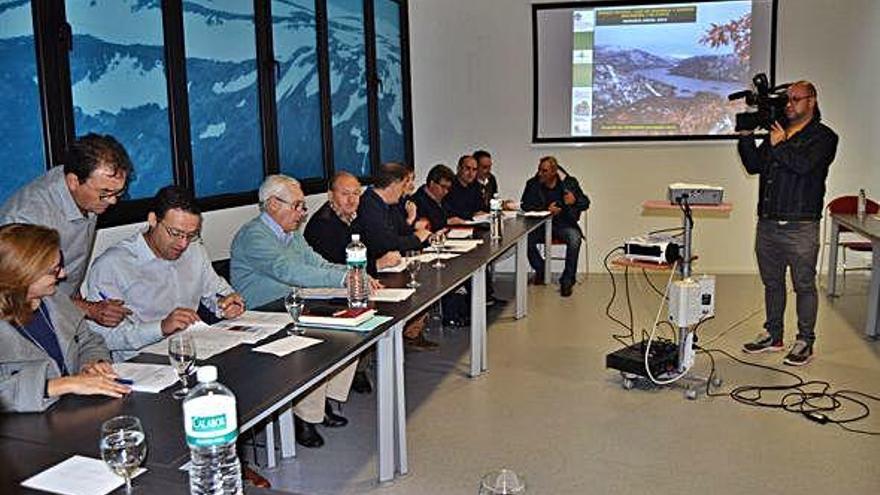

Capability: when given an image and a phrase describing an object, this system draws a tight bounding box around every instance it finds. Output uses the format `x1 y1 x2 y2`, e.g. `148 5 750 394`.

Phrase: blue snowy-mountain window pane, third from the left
183 0 263 197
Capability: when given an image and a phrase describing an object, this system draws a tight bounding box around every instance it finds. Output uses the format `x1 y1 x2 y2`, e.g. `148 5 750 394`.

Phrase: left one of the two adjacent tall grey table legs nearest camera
376 329 396 483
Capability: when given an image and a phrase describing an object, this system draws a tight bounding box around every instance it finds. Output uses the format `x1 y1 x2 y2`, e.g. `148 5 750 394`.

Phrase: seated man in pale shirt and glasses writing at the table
85 186 245 361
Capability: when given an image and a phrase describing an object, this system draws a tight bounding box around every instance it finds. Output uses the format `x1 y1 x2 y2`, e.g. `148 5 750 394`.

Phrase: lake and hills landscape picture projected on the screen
588 0 751 136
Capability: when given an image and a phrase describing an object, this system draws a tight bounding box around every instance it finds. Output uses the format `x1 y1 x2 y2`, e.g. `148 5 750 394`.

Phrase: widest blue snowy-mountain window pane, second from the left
66 0 173 198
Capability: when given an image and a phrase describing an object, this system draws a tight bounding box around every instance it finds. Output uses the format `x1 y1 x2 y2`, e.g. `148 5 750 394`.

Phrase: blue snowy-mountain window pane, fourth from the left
272 0 324 179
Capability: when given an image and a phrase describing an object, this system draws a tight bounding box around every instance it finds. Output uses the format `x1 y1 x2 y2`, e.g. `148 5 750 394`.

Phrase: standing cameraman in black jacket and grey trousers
737 81 838 366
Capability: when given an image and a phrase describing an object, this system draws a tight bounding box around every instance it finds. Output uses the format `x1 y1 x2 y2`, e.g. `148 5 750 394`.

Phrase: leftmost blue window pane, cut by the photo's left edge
0 0 46 204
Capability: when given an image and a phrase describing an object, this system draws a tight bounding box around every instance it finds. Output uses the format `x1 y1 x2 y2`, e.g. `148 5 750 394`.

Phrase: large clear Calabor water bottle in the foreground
183 366 243 495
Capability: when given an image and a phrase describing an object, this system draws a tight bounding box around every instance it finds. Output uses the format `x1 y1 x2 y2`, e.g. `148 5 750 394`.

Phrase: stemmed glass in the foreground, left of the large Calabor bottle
100 416 147 495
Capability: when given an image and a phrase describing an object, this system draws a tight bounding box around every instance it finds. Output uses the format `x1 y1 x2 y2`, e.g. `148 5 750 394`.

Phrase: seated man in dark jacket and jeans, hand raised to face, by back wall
522 156 590 297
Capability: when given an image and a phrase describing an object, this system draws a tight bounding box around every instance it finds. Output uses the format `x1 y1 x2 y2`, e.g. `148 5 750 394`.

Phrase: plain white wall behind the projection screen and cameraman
410 0 880 272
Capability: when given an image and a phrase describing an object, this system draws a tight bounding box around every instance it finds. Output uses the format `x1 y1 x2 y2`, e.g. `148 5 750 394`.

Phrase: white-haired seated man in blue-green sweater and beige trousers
230 175 357 448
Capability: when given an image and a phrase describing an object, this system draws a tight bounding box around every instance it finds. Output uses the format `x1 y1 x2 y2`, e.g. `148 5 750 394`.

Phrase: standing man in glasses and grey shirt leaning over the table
0 134 132 326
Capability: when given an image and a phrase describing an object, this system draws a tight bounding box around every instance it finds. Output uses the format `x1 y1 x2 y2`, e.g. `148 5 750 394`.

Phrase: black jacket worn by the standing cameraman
737 118 838 221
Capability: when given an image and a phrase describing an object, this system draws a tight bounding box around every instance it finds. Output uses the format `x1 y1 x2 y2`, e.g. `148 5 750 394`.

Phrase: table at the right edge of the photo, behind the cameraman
828 213 880 339
